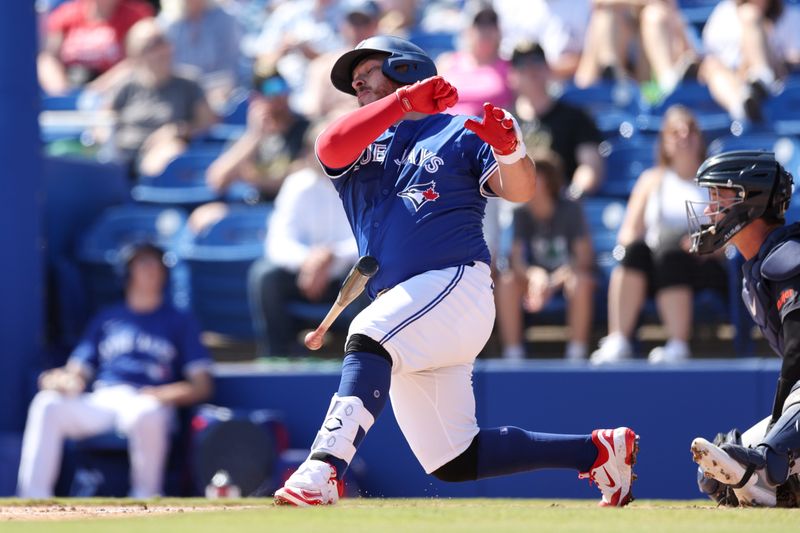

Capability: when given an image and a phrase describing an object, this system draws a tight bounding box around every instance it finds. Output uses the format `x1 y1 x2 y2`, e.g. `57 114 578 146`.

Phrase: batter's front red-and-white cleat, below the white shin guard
273 459 344 507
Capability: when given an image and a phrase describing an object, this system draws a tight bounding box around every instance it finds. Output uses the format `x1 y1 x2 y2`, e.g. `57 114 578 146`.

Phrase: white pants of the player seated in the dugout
17 385 174 498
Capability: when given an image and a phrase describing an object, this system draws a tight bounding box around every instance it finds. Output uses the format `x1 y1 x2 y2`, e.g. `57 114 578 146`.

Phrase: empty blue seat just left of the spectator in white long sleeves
177 204 272 339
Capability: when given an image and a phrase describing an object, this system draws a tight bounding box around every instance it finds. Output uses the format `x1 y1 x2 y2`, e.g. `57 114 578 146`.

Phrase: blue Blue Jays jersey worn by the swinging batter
323 114 497 298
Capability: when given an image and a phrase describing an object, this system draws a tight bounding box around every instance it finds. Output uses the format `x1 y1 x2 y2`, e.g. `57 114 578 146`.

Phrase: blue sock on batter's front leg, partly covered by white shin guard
312 352 392 479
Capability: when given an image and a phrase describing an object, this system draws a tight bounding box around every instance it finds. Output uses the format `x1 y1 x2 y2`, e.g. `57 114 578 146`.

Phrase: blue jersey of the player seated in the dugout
69 303 212 387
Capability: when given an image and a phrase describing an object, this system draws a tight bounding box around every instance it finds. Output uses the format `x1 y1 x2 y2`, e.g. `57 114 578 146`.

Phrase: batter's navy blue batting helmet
331 35 436 95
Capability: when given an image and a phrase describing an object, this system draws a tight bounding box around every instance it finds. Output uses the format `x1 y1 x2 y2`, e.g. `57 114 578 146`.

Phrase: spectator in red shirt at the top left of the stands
37 0 154 94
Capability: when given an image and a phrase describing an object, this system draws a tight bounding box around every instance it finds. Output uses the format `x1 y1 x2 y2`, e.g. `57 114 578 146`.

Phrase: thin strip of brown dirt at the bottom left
0 503 263 522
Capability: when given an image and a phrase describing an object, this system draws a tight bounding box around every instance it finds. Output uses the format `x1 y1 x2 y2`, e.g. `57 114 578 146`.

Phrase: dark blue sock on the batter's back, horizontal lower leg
477 426 597 479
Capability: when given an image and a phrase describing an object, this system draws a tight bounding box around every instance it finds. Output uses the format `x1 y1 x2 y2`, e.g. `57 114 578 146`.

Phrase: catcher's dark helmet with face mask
686 151 793 254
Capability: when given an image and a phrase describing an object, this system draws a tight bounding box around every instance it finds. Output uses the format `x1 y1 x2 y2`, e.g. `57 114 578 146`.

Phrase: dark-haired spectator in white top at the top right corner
700 0 800 122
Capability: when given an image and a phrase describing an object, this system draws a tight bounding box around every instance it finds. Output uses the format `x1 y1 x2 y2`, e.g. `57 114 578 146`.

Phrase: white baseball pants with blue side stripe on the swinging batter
349 262 495 473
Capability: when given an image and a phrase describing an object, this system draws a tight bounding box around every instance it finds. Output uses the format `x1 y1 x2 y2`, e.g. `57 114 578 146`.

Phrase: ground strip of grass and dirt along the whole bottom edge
0 499 800 533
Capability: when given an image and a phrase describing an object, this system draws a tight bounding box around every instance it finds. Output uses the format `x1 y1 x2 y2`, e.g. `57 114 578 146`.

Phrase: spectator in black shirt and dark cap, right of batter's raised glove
509 42 603 199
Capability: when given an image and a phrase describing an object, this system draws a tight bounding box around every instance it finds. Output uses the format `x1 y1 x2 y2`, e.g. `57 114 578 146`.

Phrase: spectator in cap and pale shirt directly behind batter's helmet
303 0 381 120
